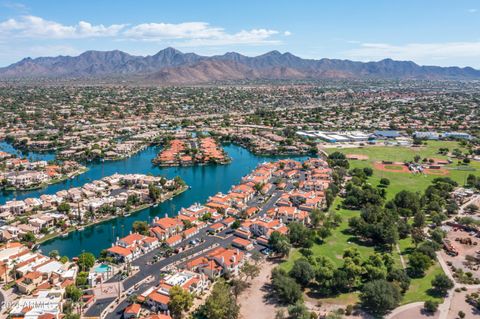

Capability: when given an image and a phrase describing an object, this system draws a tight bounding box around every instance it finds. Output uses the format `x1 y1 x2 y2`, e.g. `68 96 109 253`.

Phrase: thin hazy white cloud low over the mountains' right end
345 42 480 63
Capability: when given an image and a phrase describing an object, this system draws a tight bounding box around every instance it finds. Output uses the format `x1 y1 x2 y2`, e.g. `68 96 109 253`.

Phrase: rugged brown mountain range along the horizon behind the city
0 48 480 84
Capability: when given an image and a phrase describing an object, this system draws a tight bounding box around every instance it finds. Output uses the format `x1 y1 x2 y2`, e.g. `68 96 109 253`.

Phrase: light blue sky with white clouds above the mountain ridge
0 0 480 68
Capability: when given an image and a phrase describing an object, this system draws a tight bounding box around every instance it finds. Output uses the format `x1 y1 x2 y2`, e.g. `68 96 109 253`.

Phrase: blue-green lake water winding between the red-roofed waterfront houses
0 143 306 258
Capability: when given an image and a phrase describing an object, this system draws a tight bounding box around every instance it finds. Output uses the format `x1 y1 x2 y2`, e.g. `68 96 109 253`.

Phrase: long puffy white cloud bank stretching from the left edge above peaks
0 15 282 46
